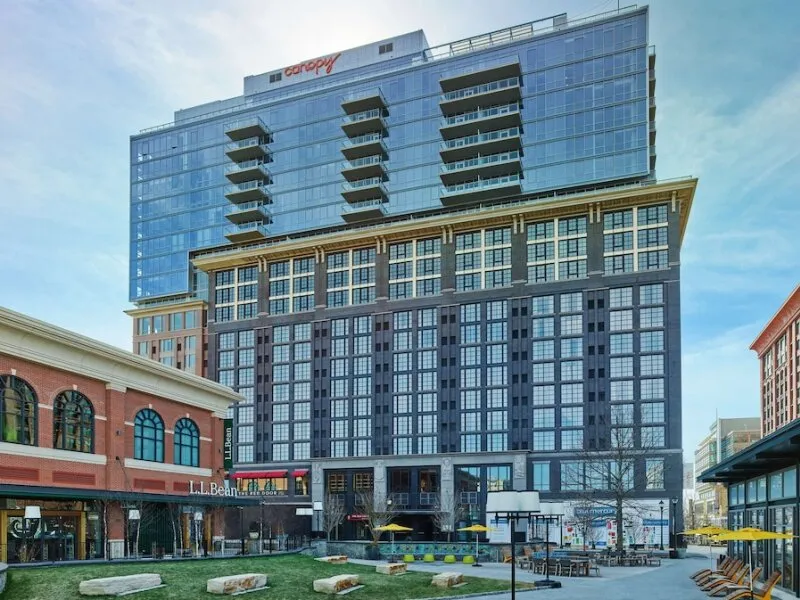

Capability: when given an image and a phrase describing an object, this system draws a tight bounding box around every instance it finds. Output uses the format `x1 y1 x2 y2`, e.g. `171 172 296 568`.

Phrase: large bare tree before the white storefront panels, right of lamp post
561 426 665 551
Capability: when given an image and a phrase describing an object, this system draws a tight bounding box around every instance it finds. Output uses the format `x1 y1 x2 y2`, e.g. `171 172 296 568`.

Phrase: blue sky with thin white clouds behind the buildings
0 0 800 460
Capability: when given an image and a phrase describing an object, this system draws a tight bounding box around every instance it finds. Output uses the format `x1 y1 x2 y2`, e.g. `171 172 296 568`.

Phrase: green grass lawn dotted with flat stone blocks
0 555 529 600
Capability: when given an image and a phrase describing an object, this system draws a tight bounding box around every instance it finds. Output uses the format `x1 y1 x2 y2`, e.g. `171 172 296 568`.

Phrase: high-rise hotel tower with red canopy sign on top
130 7 696 536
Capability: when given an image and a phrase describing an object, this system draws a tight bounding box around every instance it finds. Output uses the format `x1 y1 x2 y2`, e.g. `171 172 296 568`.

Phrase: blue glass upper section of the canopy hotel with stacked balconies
130 8 657 305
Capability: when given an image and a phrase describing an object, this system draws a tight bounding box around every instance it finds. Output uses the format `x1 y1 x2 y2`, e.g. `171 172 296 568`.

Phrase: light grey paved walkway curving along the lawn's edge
351 557 709 600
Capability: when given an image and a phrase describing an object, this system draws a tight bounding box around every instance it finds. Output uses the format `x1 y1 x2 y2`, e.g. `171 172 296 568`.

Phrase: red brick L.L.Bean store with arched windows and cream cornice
0 308 247 562
